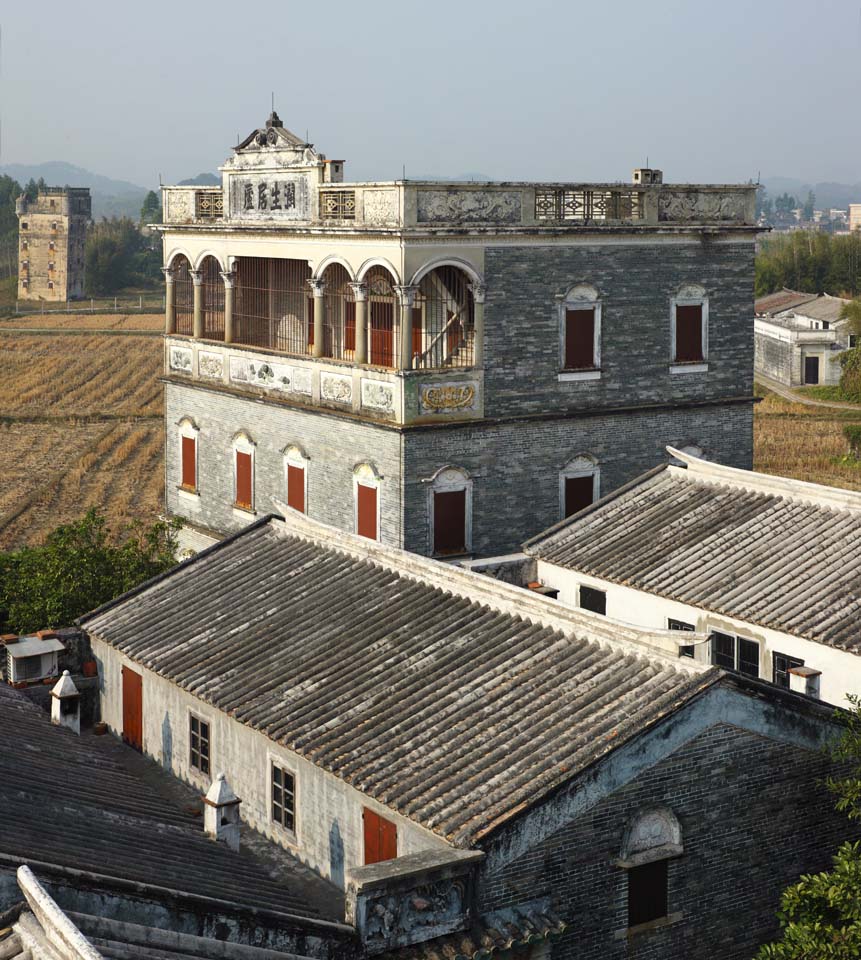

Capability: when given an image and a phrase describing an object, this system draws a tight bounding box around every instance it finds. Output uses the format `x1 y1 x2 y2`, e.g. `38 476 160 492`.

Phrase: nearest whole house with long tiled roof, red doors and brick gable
77 508 854 960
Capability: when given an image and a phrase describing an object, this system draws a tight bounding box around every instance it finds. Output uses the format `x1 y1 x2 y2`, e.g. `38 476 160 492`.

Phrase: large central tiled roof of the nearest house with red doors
83 519 720 846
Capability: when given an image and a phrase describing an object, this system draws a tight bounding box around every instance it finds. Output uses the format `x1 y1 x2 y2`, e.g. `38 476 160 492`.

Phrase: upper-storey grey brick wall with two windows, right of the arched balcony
485 238 754 417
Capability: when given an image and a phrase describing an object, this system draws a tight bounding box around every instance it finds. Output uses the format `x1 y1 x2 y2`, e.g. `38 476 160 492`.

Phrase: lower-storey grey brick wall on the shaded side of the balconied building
404 404 753 556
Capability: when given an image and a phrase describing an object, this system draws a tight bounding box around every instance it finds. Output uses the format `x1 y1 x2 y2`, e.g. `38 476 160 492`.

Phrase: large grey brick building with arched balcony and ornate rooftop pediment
160 113 757 556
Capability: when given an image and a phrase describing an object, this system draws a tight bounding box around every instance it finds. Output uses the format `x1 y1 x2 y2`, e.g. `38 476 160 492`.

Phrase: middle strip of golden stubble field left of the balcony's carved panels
0 329 162 417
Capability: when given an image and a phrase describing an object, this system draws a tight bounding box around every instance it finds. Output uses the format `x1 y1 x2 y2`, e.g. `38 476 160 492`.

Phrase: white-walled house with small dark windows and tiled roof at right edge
524 449 861 705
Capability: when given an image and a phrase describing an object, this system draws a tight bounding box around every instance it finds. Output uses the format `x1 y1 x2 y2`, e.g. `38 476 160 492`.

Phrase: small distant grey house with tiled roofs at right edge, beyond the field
754 290 858 387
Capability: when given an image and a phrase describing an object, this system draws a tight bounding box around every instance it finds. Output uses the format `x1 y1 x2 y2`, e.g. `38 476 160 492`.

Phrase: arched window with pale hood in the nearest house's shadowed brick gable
619 807 684 929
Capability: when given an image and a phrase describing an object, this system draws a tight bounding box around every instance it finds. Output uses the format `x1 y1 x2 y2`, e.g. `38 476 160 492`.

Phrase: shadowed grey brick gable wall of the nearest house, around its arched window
480 724 857 960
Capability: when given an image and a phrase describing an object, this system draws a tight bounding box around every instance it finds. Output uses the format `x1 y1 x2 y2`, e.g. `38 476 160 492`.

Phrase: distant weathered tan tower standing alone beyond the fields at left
15 187 91 300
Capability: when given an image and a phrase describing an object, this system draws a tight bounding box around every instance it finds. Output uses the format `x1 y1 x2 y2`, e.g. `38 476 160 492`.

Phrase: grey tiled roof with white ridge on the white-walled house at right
524 450 861 654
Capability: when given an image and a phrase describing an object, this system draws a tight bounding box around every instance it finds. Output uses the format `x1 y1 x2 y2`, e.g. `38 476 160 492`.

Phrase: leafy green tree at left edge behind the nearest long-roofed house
0 509 179 633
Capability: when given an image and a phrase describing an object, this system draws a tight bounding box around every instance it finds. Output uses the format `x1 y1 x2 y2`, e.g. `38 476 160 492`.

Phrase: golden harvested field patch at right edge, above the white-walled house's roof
753 393 861 490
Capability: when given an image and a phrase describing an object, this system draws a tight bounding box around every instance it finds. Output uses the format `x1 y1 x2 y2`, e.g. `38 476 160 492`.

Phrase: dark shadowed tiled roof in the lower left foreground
0 685 330 917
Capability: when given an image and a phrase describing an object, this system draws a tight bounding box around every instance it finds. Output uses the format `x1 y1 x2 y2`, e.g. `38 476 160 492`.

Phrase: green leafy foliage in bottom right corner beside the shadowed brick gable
757 695 861 960
